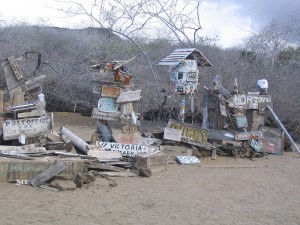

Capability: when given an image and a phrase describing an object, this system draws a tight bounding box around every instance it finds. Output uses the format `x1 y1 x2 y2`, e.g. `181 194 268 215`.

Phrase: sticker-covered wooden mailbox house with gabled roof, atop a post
158 48 212 95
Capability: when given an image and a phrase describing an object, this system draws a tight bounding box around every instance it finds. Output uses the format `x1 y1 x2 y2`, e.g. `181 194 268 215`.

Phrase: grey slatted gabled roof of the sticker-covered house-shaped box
158 48 212 67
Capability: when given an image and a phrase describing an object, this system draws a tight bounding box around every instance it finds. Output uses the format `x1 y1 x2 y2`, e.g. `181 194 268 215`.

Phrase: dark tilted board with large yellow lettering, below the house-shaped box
167 119 208 146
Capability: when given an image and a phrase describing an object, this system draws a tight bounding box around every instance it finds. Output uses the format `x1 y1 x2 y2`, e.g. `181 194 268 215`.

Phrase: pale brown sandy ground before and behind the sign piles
0 113 300 225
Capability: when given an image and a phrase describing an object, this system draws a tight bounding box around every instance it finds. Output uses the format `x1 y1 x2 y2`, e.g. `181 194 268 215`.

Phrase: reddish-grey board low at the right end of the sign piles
259 137 283 155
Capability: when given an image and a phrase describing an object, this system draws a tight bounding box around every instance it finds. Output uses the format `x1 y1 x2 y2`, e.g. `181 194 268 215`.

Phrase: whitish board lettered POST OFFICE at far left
3 116 52 140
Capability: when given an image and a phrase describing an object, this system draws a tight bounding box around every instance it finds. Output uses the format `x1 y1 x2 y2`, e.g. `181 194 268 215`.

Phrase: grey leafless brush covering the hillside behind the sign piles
0 23 300 141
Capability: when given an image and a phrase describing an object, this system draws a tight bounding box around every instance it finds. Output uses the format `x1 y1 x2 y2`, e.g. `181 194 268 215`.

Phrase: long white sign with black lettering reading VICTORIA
96 141 156 156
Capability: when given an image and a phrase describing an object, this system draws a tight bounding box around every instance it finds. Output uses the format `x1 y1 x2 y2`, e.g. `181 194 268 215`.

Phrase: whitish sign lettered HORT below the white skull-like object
229 94 272 109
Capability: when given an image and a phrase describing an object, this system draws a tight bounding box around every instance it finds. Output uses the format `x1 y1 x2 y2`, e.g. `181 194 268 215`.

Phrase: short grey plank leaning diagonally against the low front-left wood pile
30 162 66 187
